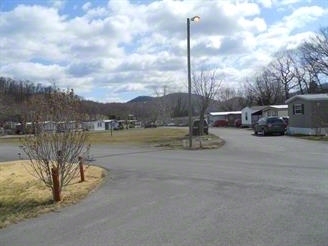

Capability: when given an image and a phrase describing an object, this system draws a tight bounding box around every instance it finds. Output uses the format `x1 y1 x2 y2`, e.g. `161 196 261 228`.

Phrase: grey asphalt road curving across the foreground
0 129 328 246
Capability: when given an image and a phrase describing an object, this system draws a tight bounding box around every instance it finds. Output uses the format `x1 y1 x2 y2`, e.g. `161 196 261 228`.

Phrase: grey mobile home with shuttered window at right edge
286 94 328 135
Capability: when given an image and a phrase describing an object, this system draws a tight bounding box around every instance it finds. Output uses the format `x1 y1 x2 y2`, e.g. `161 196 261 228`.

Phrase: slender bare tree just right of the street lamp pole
192 70 221 135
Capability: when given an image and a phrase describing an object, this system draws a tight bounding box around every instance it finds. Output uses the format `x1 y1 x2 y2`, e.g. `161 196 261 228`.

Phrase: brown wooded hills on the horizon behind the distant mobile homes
0 77 242 124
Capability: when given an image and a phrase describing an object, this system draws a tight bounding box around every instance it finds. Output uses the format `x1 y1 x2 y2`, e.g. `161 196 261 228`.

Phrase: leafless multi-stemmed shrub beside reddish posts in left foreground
22 90 90 202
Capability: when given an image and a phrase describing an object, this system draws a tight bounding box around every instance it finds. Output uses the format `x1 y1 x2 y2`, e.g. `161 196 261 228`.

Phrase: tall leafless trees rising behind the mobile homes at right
244 27 328 105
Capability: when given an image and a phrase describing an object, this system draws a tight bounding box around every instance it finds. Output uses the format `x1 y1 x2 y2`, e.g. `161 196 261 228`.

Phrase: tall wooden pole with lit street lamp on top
187 15 200 149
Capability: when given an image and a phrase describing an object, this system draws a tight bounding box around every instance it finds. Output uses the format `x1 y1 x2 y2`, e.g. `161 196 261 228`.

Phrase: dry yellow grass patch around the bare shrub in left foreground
0 161 106 228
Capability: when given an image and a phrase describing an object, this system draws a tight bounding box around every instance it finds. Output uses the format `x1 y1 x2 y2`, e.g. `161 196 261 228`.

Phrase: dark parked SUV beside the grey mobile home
254 116 286 135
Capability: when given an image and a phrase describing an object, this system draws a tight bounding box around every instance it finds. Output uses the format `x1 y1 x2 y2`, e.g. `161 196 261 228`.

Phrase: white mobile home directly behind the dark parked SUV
241 105 288 127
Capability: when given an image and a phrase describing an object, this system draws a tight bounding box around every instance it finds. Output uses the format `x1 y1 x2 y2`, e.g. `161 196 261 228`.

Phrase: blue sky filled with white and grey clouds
0 0 328 103
